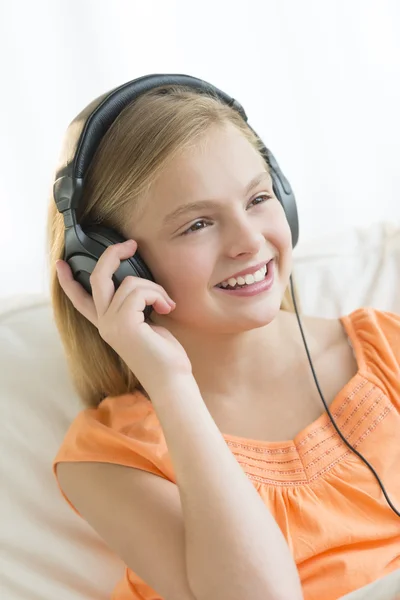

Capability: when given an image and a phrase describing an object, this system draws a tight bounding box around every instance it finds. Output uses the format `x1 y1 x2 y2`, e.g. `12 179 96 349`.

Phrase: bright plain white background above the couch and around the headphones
0 0 400 296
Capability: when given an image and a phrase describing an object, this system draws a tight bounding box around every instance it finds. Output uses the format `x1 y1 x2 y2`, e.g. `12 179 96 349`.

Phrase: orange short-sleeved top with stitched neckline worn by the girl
53 308 400 600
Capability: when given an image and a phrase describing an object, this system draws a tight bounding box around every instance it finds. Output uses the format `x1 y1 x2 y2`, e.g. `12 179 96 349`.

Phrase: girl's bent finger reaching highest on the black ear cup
90 240 137 318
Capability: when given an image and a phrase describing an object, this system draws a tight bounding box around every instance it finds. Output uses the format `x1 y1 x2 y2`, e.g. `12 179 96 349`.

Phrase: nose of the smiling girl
225 213 265 258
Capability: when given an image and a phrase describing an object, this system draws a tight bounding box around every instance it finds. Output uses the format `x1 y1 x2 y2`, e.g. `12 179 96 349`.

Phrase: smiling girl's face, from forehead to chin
124 125 292 333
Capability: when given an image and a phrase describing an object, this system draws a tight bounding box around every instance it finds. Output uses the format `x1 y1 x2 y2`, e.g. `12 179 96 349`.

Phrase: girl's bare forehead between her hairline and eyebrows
136 125 271 229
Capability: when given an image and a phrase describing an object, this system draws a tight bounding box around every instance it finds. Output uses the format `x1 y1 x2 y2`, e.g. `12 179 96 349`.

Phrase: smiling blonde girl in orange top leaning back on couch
49 78 400 600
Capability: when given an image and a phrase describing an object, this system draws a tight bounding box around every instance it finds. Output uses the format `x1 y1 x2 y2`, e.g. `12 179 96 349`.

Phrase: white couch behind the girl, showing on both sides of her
0 223 400 600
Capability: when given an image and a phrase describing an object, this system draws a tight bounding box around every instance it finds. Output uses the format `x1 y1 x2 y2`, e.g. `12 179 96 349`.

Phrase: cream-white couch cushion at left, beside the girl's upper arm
0 297 123 600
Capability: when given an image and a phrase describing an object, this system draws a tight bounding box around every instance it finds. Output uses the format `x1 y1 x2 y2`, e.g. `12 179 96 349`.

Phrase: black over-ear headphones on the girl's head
53 74 299 319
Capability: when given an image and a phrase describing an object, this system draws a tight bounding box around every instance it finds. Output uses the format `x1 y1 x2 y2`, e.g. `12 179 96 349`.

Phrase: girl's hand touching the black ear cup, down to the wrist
56 240 192 390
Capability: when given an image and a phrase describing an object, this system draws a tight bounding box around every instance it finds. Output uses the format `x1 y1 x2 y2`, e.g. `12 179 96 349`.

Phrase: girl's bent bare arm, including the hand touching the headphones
57 242 302 600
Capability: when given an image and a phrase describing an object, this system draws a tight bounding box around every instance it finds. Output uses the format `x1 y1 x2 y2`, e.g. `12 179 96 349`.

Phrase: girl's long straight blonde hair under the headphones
48 86 293 407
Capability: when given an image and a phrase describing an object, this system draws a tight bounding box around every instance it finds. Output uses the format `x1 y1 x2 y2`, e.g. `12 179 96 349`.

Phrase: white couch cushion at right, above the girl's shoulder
294 223 400 317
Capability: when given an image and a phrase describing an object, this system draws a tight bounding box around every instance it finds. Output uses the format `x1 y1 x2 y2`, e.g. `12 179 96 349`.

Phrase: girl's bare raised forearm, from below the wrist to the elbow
149 378 302 600
